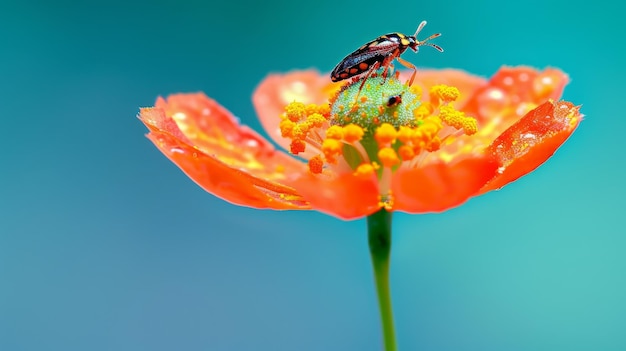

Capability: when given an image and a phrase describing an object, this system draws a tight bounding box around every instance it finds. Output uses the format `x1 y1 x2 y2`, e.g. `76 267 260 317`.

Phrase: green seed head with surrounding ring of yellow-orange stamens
280 76 478 187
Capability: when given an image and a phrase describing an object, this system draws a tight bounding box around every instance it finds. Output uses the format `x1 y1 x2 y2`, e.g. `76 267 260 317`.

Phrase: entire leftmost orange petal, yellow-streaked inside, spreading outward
139 94 309 208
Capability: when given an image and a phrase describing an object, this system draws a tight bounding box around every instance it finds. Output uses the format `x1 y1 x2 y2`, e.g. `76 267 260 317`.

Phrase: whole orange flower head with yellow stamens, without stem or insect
139 67 582 219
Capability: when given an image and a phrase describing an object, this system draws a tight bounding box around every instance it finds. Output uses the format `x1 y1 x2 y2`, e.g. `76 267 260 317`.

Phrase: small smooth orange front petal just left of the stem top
289 173 381 219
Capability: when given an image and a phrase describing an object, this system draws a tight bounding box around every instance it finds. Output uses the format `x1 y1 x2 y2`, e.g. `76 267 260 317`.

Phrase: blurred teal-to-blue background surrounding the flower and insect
0 0 626 351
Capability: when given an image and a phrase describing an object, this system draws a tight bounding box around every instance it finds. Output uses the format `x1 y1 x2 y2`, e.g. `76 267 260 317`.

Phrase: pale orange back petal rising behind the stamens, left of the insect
252 70 341 150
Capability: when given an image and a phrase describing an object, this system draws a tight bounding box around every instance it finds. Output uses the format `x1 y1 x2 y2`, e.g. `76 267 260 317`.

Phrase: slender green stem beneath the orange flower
367 208 397 351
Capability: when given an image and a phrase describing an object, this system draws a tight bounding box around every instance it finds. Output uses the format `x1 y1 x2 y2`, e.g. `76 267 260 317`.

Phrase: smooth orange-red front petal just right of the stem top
392 156 498 213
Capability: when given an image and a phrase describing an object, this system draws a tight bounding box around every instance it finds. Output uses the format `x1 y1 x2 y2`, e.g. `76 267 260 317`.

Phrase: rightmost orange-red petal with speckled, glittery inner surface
481 101 582 193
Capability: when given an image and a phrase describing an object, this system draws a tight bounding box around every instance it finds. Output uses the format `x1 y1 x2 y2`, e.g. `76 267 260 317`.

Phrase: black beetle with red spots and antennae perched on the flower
330 21 443 92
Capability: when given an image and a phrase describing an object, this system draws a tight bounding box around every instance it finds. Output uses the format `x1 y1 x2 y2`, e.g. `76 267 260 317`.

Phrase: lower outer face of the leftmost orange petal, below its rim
148 130 311 210
